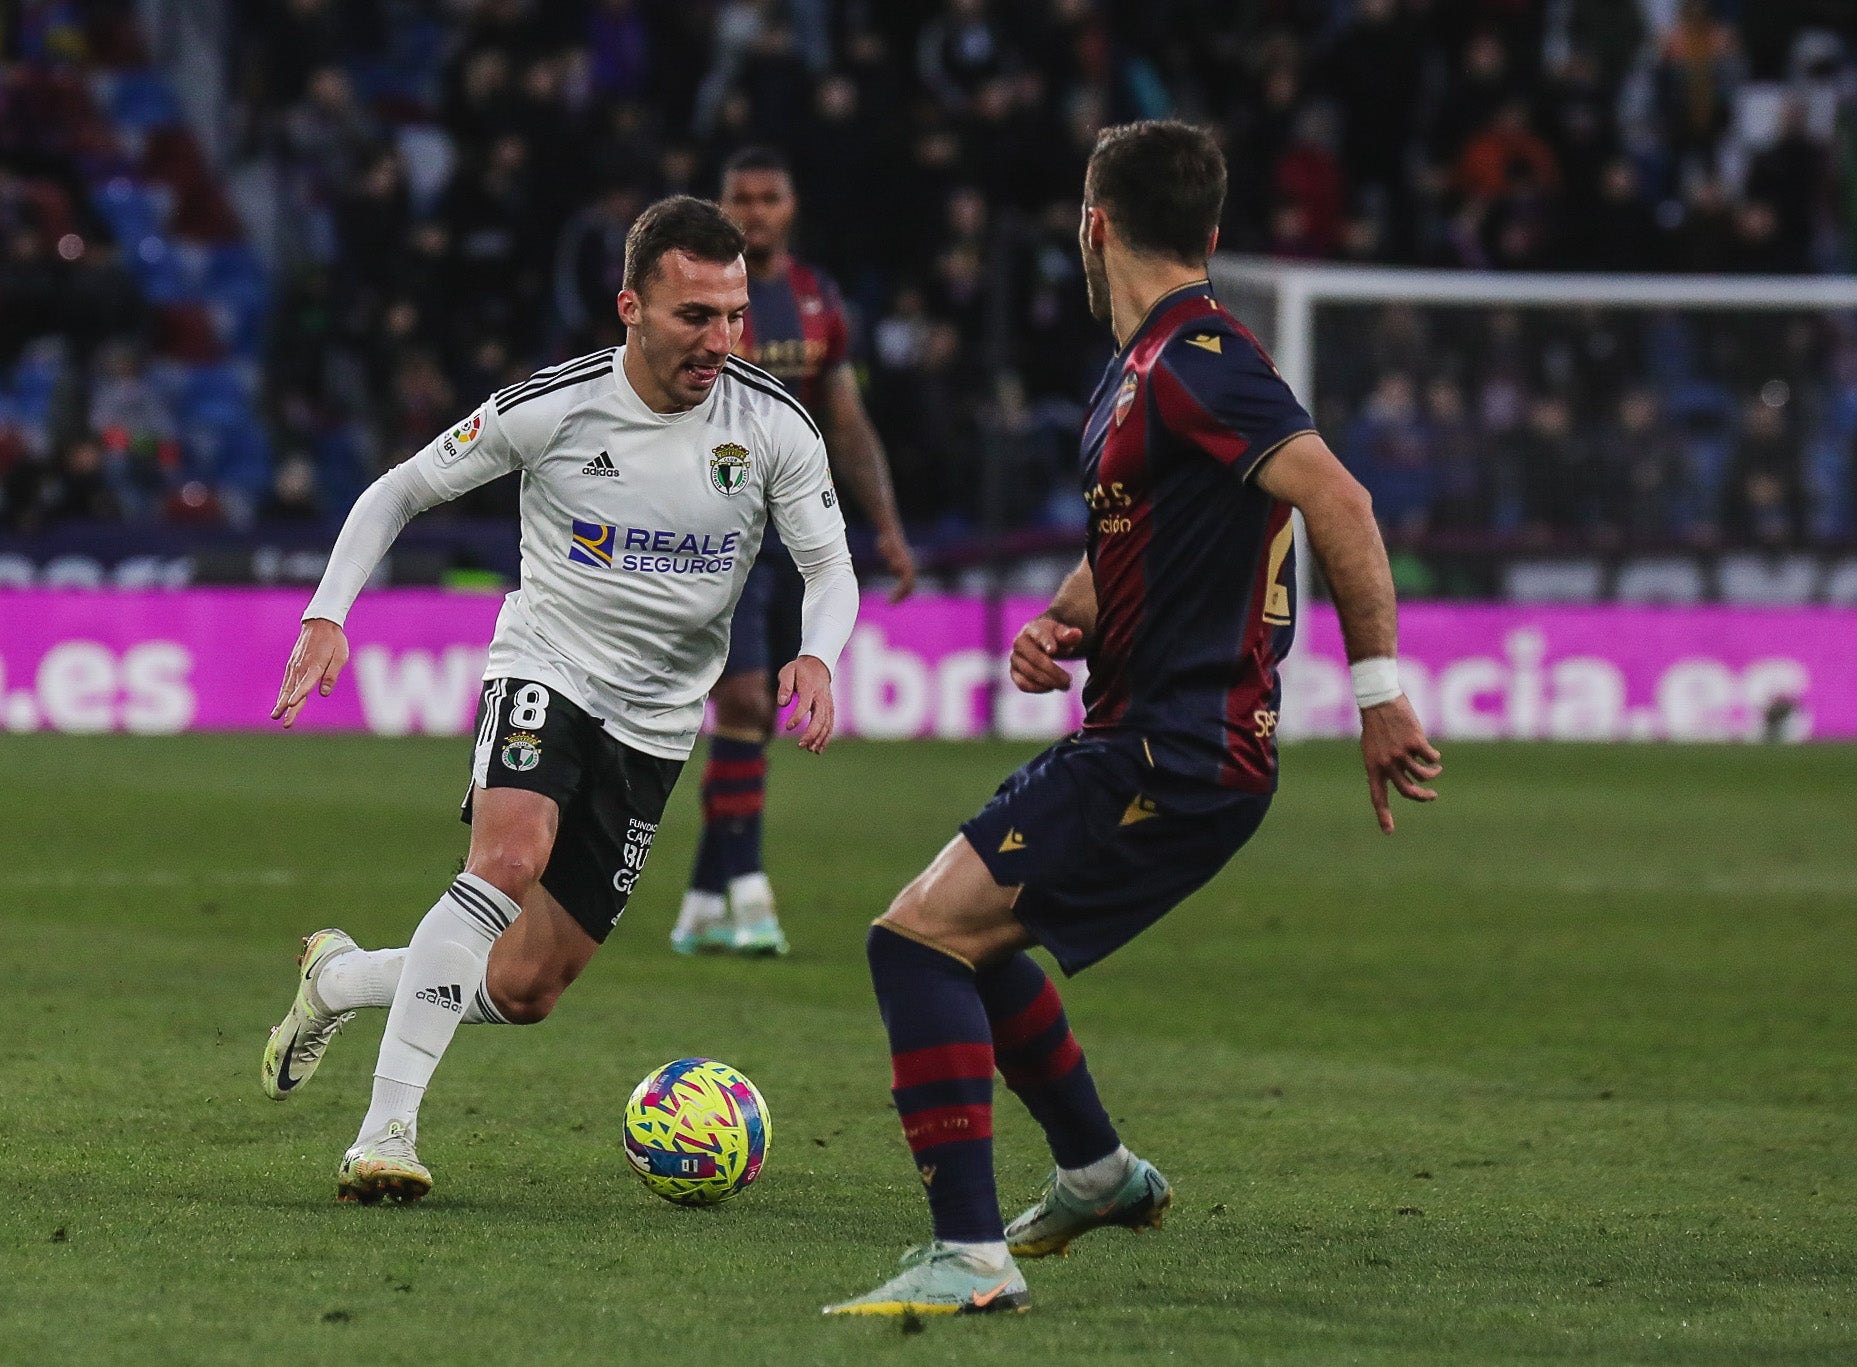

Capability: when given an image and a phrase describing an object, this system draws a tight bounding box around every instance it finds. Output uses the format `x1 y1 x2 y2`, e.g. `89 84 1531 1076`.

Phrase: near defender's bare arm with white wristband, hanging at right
1255 433 1443 836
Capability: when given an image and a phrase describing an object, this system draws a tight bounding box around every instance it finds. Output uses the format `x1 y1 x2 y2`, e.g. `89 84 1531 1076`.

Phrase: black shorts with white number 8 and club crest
464 678 683 944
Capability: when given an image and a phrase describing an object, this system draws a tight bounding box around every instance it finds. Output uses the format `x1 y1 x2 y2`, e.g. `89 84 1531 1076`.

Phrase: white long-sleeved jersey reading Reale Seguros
305 347 858 760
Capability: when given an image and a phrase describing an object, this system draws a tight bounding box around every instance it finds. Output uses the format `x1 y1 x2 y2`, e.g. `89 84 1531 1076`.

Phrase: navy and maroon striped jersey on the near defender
1083 280 1313 793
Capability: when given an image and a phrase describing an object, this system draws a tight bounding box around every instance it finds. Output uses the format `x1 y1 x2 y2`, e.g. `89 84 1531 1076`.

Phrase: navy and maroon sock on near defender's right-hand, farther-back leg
975 953 1122 1168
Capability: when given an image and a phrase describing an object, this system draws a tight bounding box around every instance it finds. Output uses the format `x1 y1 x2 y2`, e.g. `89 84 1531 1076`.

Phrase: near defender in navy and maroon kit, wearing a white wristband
826 121 1439 1315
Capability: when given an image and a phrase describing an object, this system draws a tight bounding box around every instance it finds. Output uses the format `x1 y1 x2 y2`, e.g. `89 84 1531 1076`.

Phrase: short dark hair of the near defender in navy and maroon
1083 119 1226 266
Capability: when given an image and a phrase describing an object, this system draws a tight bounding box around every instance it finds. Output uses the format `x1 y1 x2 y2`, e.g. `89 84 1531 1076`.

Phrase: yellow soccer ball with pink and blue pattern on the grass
626 1059 771 1205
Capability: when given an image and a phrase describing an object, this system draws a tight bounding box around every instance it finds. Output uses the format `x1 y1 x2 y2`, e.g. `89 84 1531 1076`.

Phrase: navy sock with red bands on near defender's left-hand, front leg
867 921 1005 1243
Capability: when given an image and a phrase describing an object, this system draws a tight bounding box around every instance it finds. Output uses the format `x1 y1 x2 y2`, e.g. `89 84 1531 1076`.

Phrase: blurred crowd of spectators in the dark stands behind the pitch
0 0 1857 557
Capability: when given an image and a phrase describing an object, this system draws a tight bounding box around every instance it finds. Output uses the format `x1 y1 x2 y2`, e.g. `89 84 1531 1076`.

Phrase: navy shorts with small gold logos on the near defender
960 732 1270 973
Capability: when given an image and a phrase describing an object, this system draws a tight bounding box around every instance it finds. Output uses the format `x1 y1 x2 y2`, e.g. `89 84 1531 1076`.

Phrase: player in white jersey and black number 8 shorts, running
262 195 858 1204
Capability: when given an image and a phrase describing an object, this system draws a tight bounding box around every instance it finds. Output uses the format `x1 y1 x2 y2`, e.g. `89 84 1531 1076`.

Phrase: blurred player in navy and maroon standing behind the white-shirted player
670 149 916 955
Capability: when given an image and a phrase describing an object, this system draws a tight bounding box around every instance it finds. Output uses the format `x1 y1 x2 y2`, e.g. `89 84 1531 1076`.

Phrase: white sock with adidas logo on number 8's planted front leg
357 873 522 1142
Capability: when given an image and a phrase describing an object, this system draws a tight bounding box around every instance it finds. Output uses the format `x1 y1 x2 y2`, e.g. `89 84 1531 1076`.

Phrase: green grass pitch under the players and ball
0 736 1857 1367
